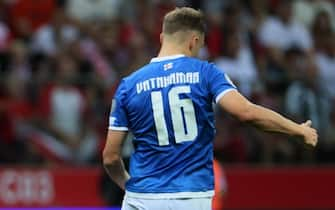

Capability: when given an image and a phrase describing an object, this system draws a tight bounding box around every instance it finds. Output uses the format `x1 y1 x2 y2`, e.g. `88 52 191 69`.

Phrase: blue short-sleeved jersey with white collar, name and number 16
109 55 235 198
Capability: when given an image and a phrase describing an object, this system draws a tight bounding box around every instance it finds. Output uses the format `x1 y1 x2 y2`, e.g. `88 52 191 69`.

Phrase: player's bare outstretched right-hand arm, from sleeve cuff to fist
219 91 318 146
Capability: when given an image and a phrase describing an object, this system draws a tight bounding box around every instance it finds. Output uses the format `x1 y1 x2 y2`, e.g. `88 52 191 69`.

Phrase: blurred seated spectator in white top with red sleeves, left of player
34 53 98 164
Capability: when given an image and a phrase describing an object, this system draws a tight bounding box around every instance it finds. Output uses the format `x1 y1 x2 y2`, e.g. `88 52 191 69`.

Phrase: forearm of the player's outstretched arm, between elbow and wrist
248 104 303 136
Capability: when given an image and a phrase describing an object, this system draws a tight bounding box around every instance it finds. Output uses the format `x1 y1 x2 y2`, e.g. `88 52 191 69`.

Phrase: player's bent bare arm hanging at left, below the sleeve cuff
102 130 129 190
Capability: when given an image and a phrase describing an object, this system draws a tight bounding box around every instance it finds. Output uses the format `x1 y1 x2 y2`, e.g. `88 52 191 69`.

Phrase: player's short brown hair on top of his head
163 7 206 34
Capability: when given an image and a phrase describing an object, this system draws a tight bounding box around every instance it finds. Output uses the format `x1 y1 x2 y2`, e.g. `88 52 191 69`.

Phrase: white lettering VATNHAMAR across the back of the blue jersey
136 72 199 94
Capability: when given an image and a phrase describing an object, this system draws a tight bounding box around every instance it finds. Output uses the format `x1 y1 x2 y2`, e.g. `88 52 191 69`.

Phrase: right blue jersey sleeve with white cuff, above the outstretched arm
207 64 237 103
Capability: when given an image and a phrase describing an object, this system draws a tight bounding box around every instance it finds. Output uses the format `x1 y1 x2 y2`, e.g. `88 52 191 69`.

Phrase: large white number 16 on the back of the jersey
151 86 198 146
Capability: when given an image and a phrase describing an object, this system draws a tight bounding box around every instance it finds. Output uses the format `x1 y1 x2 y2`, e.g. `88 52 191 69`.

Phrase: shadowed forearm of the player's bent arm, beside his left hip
104 158 129 190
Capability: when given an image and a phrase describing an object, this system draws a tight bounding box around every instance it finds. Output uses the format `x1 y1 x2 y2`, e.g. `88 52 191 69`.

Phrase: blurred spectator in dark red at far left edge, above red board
0 69 33 163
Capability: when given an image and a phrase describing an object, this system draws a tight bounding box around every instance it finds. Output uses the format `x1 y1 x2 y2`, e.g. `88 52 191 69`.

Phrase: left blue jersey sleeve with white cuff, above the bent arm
109 80 128 131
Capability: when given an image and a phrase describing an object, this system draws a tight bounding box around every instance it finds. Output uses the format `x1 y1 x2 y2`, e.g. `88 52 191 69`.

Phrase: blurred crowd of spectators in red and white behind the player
0 0 335 165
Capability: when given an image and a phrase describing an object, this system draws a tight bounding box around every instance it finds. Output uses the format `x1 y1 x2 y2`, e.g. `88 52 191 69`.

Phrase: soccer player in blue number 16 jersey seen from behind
103 7 317 210
